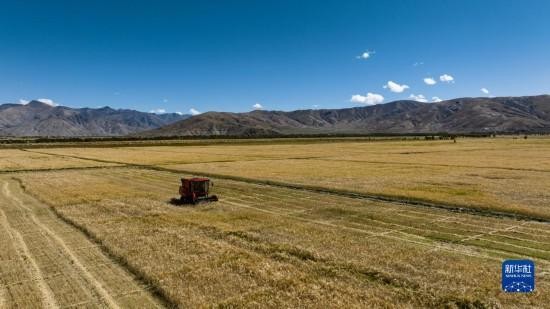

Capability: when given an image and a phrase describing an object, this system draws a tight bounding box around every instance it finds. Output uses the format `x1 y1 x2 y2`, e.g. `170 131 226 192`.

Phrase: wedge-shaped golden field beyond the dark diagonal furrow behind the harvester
32 138 550 220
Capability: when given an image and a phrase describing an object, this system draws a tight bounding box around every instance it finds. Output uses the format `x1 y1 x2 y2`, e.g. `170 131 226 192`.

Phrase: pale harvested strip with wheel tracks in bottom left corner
0 178 161 308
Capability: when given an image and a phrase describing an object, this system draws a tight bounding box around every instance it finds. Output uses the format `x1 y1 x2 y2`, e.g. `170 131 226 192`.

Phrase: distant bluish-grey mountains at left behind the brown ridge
0 101 189 136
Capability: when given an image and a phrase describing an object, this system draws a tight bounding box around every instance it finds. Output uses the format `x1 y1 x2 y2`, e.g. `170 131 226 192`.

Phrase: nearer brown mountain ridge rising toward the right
139 95 550 136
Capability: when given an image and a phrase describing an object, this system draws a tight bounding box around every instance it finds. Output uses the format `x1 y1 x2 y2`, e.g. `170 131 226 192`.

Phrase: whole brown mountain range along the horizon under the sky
0 95 550 137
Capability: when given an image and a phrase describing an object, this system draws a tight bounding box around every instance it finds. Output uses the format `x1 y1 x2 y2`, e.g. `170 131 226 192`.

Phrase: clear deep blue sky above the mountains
0 0 550 113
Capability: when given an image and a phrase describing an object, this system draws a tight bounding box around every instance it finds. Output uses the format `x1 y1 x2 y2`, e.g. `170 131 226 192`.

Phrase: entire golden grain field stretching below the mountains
0 137 550 308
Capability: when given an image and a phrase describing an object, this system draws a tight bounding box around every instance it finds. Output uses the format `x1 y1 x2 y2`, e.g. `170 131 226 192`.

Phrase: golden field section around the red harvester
17 168 550 306
